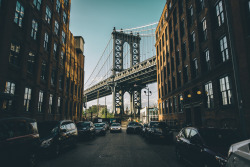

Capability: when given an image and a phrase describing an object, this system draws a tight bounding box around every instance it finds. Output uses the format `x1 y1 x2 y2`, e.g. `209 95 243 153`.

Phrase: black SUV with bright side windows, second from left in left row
38 120 78 156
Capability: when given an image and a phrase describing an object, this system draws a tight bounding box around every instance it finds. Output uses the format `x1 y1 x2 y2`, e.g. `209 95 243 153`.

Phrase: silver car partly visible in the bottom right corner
226 139 250 167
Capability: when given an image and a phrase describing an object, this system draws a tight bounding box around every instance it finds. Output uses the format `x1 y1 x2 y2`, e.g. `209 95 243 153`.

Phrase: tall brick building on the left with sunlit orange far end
0 0 84 121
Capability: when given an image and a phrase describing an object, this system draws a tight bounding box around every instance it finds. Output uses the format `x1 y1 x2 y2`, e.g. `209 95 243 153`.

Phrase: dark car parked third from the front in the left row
76 121 96 139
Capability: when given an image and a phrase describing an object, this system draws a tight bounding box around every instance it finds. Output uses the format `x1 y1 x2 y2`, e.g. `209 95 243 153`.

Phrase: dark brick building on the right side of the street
156 0 250 134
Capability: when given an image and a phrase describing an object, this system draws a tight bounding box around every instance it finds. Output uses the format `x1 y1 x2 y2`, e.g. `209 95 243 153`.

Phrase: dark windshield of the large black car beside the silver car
199 129 241 146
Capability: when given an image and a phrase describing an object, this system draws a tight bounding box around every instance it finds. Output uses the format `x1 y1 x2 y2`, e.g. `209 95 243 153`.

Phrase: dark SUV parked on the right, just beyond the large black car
145 121 173 141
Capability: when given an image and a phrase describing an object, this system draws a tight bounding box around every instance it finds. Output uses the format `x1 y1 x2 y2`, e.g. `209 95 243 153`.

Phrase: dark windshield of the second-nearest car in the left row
37 121 59 138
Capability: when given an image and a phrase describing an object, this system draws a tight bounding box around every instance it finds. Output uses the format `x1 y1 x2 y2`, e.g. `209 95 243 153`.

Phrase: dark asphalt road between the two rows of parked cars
38 129 185 167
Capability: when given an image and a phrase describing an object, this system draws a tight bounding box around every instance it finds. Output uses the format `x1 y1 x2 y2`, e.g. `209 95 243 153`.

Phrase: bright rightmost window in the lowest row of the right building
220 76 232 106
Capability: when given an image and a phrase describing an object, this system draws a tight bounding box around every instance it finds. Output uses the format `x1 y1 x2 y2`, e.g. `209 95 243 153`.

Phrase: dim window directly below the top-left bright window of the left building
9 42 20 66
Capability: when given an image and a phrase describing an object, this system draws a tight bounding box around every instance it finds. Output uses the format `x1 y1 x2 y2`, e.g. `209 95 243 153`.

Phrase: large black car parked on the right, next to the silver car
176 127 241 167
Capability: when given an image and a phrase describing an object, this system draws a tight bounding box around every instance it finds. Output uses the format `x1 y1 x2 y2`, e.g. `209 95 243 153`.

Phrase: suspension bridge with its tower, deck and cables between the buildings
84 23 158 117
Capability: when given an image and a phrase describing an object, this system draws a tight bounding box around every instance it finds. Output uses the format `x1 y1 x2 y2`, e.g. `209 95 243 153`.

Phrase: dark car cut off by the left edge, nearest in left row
0 117 39 167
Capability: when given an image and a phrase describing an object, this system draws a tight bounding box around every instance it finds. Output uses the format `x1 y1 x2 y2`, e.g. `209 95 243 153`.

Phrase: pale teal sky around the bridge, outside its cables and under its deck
70 0 166 109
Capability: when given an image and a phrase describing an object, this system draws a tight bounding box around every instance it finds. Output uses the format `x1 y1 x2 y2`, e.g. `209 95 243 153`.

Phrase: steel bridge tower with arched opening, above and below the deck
112 28 141 117
